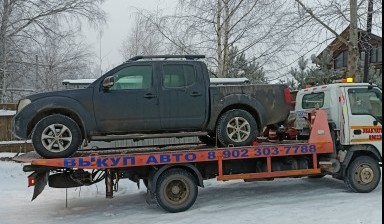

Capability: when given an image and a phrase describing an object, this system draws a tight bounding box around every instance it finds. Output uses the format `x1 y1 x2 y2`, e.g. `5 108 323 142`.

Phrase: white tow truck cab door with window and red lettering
343 86 383 152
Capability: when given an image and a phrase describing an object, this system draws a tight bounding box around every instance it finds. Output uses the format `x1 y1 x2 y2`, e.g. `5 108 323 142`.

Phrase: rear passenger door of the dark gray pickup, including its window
160 62 209 130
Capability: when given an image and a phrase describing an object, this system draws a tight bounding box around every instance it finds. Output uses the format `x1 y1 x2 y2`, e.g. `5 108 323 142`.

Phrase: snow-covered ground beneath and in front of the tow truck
0 153 382 224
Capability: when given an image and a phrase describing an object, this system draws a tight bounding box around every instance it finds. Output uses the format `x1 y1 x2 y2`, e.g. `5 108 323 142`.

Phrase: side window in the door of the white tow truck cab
348 88 383 119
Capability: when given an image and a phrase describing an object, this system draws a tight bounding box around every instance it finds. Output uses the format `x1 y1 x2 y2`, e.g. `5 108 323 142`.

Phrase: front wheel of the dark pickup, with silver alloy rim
32 114 83 159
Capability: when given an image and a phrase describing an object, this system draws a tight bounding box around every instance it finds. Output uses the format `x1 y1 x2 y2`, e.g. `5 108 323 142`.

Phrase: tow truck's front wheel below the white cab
345 156 381 193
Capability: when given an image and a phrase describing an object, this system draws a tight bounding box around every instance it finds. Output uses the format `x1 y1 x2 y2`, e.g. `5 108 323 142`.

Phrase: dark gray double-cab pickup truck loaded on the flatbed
14 55 290 158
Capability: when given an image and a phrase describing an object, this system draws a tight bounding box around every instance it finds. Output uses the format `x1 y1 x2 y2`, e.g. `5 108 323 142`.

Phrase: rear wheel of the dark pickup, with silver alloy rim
216 109 258 147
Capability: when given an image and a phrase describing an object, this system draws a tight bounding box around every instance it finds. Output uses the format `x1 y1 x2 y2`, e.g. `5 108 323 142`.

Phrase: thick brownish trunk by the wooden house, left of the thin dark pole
347 0 362 82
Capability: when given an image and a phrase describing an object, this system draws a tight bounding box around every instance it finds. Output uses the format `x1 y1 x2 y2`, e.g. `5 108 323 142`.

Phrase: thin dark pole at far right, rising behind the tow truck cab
363 0 373 82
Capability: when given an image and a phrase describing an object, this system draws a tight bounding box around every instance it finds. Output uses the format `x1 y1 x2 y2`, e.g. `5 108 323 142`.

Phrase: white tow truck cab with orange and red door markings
295 83 383 158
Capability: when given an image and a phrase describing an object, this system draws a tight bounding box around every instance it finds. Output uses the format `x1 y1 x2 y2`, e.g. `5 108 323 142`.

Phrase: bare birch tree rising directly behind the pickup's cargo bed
180 0 298 77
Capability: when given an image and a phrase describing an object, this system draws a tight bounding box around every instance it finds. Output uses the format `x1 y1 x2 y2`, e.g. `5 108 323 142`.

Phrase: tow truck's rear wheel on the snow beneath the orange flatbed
156 169 198 213
